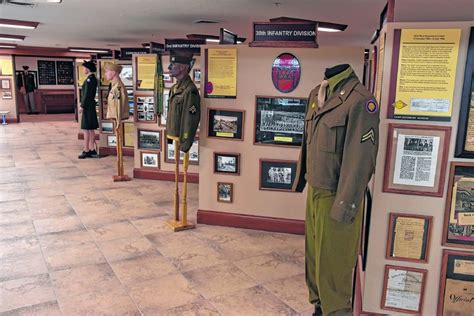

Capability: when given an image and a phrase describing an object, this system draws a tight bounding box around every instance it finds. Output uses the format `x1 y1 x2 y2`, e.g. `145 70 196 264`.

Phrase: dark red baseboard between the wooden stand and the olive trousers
197 210 304 235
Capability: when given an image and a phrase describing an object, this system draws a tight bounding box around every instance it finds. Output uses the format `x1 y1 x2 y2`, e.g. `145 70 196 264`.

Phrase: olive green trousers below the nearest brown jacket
305 185 363 315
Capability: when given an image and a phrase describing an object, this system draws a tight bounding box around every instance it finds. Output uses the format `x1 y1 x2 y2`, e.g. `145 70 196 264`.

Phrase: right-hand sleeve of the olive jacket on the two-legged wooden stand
179 89 201 153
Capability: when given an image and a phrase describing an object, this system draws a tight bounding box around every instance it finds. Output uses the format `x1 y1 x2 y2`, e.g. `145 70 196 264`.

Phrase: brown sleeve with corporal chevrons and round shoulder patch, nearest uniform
330 98 379 224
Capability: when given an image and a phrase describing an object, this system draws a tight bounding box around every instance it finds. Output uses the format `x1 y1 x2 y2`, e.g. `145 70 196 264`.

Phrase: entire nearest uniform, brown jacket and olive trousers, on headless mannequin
293 65 379 316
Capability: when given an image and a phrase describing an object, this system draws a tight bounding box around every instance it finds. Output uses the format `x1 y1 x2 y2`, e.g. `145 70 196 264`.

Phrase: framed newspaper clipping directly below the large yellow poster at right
383 124 451 197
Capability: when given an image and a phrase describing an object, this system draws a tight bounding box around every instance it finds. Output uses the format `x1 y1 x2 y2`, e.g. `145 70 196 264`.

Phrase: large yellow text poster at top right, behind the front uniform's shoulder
393 29 461 121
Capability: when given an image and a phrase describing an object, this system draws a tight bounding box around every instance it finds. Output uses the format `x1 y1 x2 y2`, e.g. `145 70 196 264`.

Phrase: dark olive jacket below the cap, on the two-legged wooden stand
166 75 201 152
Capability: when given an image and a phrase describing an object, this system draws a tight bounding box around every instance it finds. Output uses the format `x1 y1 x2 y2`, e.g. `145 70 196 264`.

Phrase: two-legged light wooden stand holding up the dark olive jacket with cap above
166 136 196 232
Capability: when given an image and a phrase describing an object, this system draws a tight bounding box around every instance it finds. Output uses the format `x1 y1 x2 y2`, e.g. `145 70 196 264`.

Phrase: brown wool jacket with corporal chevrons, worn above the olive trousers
293 74 380 223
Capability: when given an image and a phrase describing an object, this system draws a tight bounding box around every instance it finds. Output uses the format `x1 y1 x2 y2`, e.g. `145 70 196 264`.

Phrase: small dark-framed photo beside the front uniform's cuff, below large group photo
259 159 297 192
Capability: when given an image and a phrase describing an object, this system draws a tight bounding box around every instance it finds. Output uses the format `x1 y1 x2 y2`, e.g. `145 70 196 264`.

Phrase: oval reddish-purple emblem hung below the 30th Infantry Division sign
272 53 301 93
